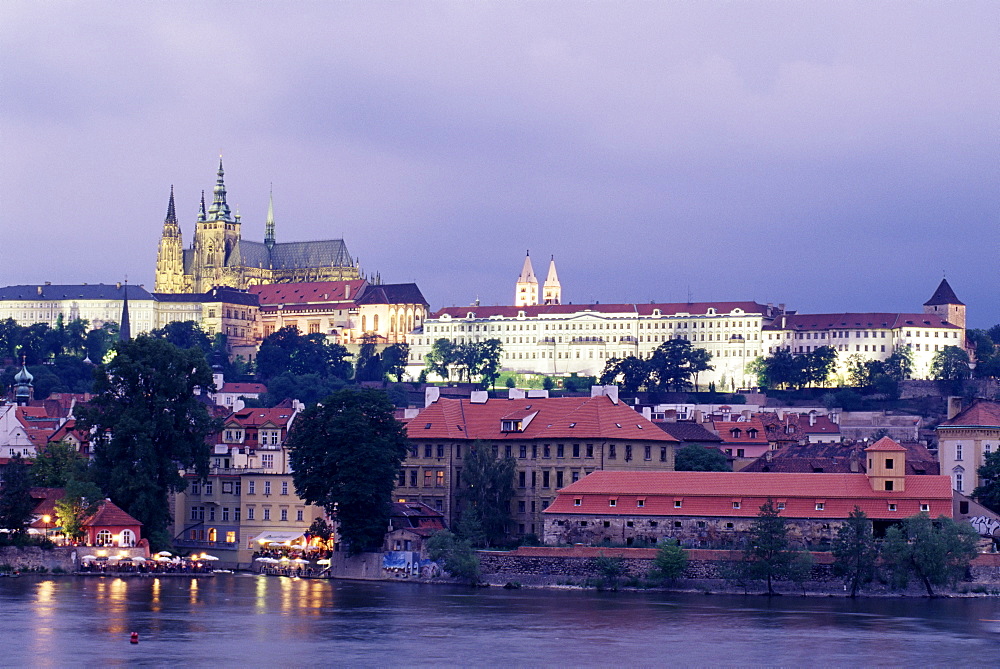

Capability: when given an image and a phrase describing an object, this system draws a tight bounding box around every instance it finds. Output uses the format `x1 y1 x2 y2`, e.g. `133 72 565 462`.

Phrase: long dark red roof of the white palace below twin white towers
433 302 768 318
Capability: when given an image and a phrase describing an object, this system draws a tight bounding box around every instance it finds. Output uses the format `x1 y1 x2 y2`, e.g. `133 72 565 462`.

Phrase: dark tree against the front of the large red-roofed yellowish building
458 441 517 546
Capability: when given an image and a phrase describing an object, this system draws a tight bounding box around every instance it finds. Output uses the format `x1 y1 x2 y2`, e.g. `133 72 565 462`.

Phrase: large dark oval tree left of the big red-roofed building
287 388 407 554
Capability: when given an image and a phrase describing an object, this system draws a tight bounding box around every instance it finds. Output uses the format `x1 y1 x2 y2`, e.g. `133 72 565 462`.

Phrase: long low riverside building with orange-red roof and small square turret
545 438 954 547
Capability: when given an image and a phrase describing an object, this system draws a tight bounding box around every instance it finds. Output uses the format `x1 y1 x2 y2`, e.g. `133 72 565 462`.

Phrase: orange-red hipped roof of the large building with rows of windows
406 395 677 442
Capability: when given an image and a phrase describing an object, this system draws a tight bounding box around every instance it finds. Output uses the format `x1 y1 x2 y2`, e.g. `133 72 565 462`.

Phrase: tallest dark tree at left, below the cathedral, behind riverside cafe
78 336 220 547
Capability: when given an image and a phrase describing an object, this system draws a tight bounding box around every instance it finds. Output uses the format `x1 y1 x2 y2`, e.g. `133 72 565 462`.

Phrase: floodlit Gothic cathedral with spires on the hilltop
154 158 361 293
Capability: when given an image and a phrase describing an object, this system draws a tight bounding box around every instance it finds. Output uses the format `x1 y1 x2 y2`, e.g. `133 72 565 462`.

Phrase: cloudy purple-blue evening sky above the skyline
0 0 1000 327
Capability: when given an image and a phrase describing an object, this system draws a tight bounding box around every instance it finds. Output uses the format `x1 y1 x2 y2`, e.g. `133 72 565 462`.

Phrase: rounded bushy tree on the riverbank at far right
882 513 979 597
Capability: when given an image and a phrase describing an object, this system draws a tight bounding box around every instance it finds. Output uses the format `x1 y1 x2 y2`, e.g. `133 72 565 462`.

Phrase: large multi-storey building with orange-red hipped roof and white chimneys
394 386 678 536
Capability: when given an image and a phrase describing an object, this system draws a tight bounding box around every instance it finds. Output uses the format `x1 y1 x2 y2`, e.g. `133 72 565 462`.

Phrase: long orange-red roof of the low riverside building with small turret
545 470 952 519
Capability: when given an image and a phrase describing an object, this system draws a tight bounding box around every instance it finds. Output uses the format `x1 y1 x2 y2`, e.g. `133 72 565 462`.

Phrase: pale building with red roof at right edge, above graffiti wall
936 400 1000 494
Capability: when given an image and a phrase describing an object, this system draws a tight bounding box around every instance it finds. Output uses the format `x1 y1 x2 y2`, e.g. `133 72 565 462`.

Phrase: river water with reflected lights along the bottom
0 574 1000 667
